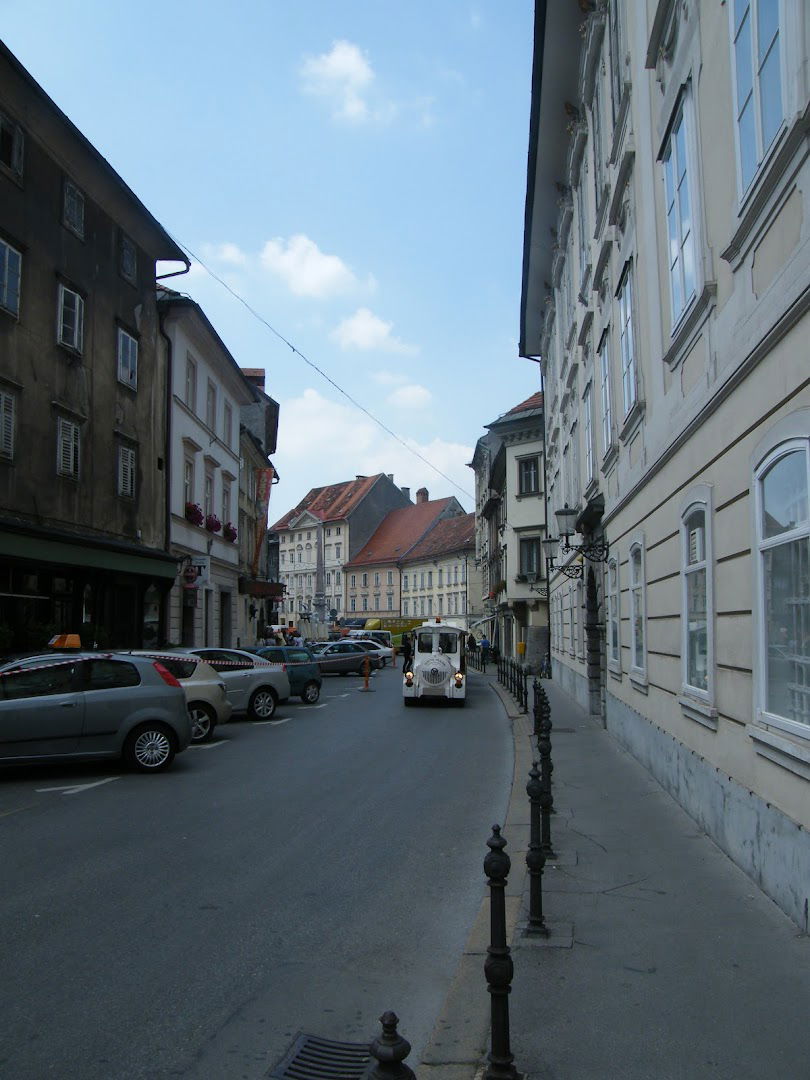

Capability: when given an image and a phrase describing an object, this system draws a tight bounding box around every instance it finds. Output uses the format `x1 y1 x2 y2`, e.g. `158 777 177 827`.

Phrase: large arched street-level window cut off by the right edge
756 438 810 735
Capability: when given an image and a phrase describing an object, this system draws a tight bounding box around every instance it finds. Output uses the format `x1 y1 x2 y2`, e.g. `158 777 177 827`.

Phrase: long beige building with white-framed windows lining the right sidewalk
521 0 810 930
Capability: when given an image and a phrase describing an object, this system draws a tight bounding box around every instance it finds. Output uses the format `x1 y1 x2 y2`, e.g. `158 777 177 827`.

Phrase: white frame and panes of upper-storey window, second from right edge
661 84 700 330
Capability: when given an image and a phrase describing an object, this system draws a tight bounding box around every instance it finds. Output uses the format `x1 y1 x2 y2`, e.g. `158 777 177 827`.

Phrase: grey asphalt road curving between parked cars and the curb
0 667 512 1080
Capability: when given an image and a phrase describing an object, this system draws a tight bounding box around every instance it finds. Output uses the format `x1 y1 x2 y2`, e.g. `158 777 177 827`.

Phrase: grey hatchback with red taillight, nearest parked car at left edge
0 652 191 772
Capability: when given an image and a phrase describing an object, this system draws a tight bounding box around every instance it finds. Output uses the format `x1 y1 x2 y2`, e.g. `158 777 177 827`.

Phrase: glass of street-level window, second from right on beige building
680 502 713 698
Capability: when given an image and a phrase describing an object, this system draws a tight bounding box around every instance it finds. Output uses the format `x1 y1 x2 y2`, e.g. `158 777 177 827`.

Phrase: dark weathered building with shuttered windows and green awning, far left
0 43 188 649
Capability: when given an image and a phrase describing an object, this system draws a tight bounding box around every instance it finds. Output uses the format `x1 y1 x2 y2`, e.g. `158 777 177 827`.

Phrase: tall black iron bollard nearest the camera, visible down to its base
484 825 519 1080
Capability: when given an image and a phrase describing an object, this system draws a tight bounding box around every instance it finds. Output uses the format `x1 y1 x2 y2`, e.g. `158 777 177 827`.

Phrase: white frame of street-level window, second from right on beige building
680 485 715 706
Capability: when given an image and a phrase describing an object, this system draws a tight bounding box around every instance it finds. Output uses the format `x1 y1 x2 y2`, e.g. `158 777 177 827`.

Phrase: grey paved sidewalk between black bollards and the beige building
494 675 810 1080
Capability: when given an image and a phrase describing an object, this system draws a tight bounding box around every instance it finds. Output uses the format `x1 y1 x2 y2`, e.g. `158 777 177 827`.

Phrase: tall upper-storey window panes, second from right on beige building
662 95 694 325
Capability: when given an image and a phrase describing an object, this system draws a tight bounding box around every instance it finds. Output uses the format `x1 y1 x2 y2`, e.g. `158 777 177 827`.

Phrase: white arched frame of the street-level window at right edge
752 434 810 740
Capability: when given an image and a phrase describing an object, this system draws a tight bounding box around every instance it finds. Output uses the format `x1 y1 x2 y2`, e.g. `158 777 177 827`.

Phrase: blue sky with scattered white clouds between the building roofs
0 0 540 522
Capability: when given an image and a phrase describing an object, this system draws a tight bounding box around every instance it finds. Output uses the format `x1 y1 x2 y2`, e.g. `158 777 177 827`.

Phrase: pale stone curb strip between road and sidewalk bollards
417 672 532 1080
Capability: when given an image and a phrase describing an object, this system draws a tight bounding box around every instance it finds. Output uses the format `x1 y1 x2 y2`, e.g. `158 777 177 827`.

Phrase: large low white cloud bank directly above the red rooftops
270 389 474 511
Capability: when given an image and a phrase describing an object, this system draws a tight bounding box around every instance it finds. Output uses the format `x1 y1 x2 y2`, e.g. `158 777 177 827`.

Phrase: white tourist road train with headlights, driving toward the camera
402 618 467 707
